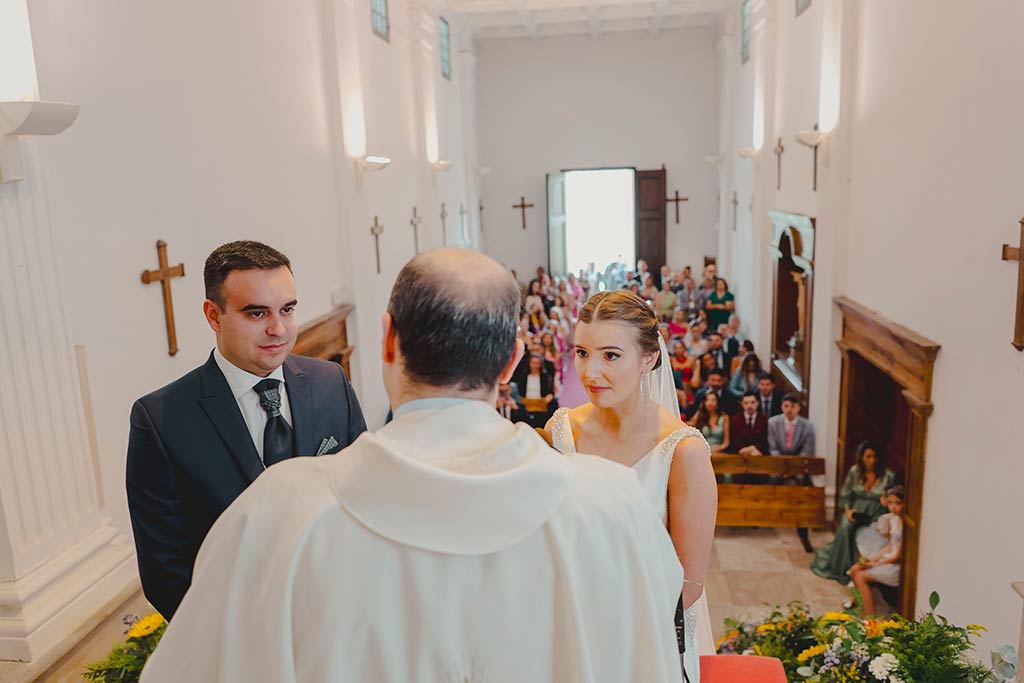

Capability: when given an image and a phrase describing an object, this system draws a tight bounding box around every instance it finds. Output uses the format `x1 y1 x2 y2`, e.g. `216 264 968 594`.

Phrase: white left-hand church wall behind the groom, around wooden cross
24 0 464 530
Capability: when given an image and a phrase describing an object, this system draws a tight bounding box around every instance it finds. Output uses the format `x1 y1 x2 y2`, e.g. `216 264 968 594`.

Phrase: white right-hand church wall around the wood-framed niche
733 0 1024 659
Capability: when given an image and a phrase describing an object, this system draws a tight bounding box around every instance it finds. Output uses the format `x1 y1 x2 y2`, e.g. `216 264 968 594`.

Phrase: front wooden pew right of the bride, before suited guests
711 455 825 528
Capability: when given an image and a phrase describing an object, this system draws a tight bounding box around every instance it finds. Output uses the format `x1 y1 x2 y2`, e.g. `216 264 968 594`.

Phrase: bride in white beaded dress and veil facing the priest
545 290 718 683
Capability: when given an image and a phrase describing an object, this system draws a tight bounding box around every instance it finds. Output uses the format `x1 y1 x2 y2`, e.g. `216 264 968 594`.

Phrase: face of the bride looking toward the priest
575 321 656 408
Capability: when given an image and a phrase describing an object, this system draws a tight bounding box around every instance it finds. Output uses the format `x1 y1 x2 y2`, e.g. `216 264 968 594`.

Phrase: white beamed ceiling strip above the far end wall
453 0 736 40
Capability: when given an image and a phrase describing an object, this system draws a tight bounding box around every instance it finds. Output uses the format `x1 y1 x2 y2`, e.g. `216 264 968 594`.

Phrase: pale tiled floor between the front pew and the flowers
705 527 850 639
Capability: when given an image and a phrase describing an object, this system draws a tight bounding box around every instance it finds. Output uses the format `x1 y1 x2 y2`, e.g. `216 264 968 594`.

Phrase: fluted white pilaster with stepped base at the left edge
0 139 138 661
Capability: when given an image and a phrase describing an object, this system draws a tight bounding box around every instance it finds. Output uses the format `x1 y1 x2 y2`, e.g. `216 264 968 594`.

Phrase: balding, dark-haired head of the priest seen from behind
381 249 523 409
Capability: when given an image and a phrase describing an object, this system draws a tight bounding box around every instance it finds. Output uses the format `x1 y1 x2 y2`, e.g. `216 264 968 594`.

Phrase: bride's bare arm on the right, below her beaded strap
669 437 718 607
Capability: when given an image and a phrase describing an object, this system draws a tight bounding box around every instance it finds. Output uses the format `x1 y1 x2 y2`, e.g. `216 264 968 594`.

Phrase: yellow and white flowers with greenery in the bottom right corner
717 593 1018 683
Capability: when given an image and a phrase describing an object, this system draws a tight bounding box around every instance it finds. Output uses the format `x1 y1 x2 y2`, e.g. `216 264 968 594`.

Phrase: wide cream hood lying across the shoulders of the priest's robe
331 400 574 555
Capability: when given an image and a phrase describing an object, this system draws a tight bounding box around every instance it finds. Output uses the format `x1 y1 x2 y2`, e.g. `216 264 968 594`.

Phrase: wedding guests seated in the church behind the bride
497 260 904 614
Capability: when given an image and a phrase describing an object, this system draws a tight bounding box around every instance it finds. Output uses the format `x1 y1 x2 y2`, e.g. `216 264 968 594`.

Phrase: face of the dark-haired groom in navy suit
206 267 297 377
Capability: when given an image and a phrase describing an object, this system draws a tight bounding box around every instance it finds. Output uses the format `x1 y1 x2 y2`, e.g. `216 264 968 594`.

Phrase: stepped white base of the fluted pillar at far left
0 519 138 661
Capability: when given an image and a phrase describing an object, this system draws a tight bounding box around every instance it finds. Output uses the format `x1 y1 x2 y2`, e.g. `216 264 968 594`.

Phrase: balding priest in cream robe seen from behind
142 249 682 683
